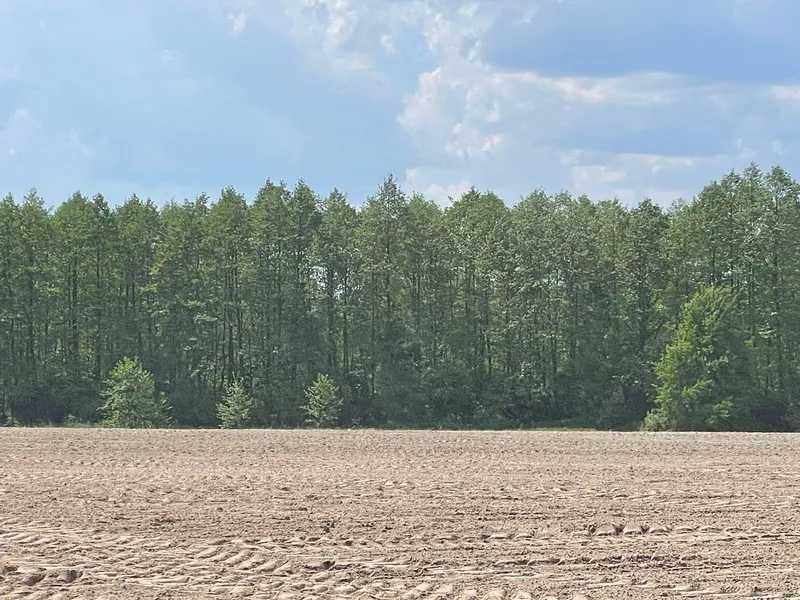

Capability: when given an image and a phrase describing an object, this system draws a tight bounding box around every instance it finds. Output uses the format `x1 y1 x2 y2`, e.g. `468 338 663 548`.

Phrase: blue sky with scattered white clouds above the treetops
0 0 800 206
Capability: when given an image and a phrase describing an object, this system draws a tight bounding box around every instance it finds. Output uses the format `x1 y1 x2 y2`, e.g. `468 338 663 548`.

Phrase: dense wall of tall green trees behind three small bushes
0 166 800 429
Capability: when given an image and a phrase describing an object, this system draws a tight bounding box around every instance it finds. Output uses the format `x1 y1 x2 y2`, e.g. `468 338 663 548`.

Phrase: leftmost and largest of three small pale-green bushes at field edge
100 357 170 429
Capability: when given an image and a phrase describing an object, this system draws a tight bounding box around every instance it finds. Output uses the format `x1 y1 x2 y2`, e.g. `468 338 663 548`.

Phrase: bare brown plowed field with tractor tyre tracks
0 429 800 600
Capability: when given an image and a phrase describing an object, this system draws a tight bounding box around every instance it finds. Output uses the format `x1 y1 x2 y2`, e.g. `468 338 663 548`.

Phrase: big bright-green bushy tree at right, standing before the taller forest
645 287 758 430
